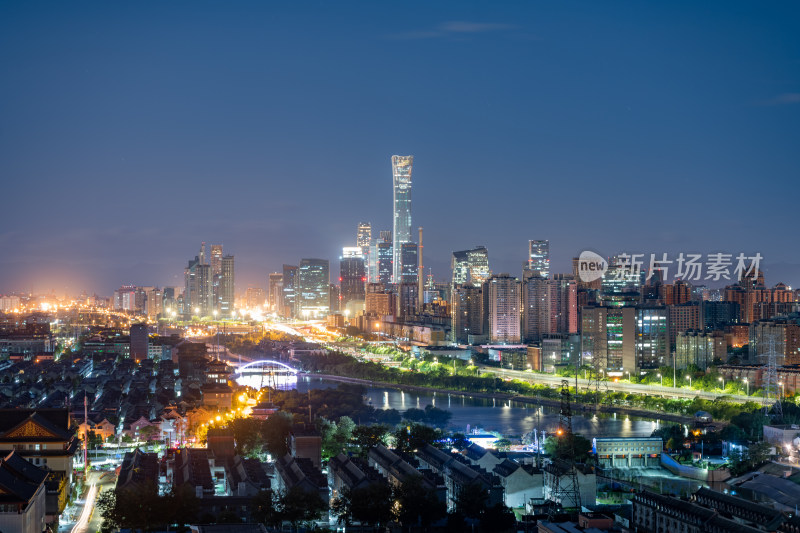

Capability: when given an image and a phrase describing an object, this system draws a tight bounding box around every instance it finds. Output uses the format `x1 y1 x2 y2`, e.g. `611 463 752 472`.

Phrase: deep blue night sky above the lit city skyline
0 1 800 295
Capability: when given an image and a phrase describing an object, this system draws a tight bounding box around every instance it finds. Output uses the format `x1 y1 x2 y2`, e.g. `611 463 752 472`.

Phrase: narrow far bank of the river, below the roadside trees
298 372 708 426
